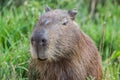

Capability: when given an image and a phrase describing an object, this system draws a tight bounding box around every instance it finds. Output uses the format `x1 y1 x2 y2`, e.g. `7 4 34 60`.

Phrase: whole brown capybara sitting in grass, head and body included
29 8 102 80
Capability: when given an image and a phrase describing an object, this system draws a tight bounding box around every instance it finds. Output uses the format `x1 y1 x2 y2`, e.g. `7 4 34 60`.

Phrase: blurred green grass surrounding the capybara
0 0 120 80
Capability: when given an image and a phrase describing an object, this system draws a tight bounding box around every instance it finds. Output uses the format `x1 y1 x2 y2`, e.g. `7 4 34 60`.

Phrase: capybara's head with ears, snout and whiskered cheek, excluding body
31 7 79 61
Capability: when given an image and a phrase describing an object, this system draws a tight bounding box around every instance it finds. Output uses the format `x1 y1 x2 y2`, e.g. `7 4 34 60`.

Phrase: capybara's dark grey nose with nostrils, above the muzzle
31 33 47 46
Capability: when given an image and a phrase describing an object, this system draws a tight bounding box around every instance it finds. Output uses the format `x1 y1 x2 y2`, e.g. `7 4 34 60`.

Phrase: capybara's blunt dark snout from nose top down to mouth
31 32 48 61
